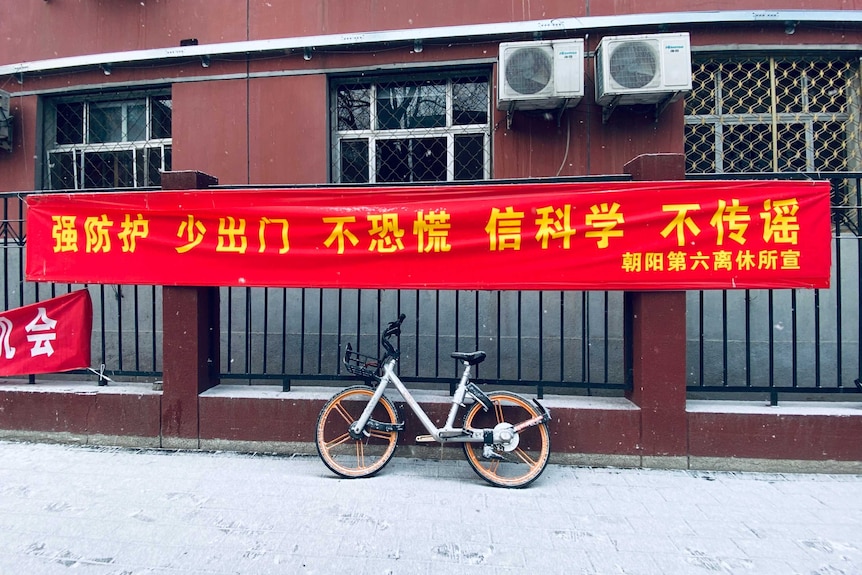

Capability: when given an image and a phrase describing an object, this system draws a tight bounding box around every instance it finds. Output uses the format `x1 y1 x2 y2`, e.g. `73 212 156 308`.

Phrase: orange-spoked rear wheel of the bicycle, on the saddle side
464 391 551 487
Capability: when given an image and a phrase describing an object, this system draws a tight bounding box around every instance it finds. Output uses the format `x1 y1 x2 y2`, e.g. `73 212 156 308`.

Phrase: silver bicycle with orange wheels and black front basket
315 314 551 487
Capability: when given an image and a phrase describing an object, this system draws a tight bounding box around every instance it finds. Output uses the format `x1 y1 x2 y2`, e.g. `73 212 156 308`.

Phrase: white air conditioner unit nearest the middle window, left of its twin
497 39 584 111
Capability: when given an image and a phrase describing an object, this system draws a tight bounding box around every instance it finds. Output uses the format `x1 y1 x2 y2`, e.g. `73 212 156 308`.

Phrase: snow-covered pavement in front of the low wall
0 441 862 575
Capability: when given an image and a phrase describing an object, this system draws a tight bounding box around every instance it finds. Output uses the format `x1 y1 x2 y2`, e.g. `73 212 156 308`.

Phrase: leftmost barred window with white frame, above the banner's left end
45 92 171 190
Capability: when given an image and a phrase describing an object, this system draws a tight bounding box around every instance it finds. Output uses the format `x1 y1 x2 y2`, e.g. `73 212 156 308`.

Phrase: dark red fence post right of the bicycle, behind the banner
624 154 688 466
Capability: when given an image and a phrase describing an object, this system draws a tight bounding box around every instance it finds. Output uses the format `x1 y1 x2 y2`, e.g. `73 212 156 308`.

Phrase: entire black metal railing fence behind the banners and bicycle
0 173 862 400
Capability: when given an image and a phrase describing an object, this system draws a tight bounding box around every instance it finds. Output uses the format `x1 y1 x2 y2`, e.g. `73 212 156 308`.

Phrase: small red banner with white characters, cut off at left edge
0 290 93 376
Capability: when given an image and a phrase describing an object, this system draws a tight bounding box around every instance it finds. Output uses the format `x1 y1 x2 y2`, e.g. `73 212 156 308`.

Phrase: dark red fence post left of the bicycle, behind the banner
161 171 220 449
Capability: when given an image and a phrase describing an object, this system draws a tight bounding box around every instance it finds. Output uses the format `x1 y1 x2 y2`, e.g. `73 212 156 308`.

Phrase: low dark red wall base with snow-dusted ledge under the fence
0 382 862 473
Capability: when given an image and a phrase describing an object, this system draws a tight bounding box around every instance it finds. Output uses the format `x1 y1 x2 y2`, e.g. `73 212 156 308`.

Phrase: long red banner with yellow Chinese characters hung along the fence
26 181 831 290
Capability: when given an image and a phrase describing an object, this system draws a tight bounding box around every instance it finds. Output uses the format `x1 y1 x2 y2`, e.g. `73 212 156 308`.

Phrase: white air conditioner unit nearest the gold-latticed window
596 32 691 106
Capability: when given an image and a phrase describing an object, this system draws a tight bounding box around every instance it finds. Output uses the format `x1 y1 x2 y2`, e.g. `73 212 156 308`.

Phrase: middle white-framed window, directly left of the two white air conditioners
332 72 491 184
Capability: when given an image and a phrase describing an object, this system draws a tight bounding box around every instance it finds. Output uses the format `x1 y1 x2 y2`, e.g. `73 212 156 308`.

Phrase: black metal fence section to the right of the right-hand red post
687 172 862 403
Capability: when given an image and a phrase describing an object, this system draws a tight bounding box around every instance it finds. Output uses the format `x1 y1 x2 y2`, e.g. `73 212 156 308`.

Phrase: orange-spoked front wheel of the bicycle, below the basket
314 386 398 477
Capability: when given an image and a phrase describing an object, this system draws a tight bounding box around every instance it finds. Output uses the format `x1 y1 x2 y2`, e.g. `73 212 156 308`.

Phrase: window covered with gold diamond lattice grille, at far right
685 56 860 173
